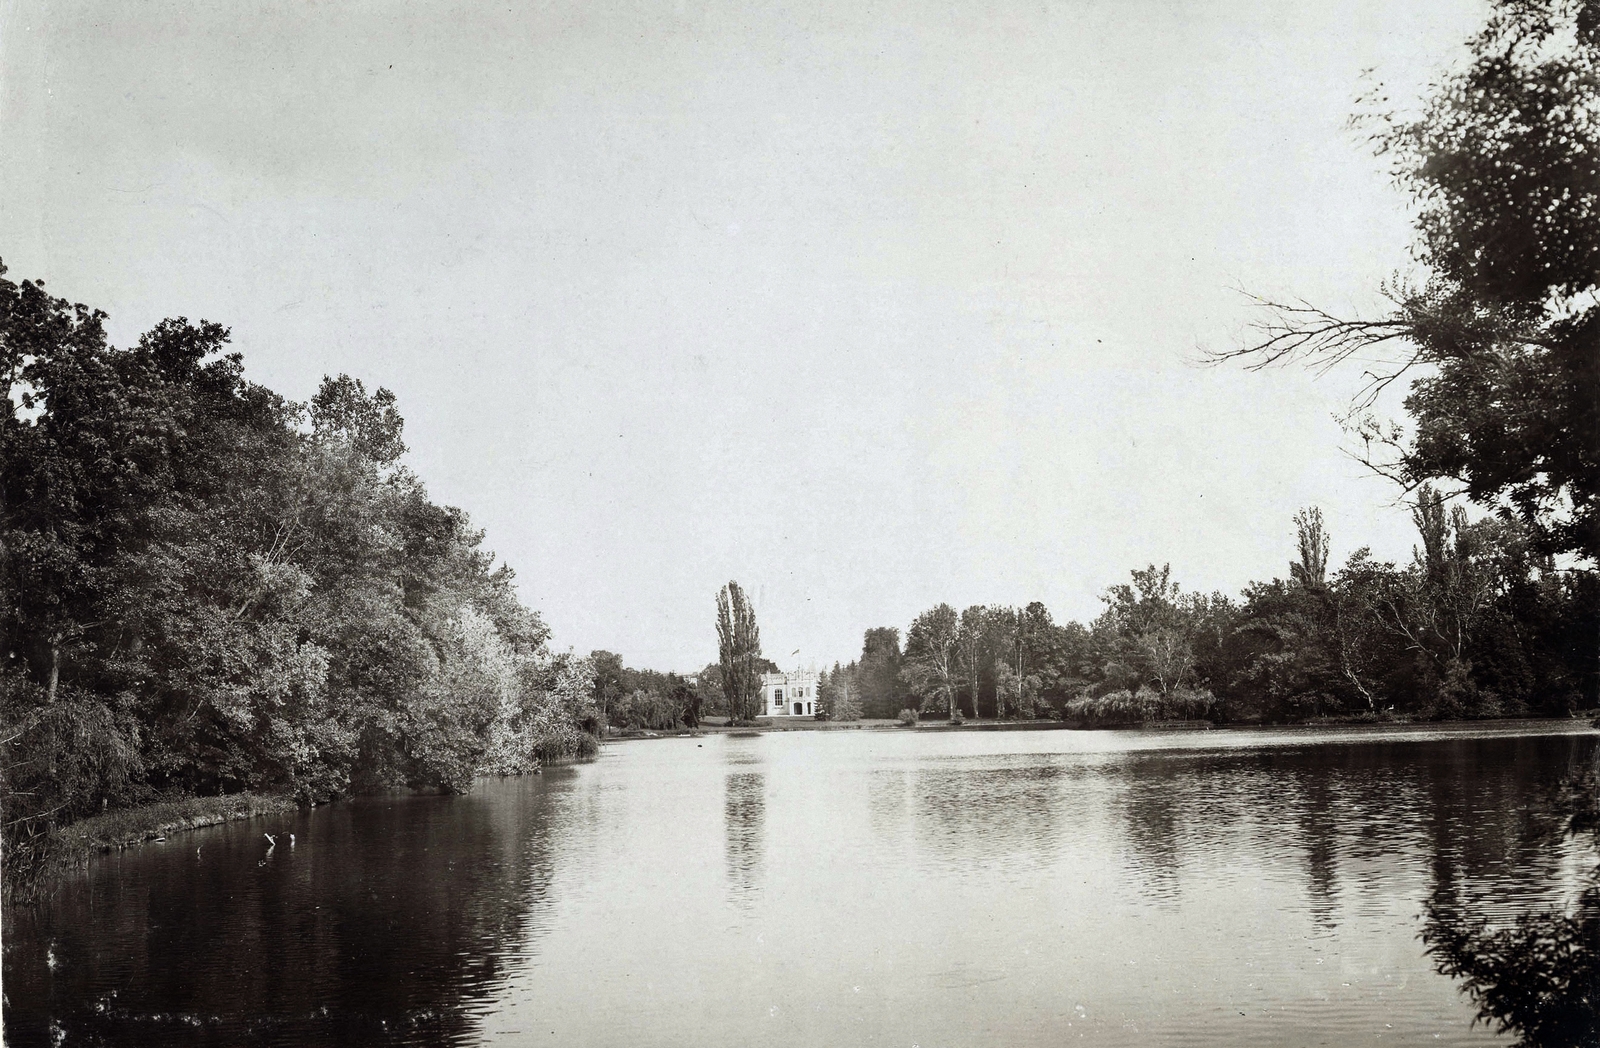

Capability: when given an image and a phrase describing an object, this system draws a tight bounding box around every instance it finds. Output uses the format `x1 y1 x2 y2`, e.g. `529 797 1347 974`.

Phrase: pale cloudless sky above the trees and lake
0 0 1485 670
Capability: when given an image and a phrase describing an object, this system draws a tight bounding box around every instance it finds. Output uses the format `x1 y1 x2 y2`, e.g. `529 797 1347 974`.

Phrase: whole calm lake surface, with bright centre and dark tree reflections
5 725 1597 1048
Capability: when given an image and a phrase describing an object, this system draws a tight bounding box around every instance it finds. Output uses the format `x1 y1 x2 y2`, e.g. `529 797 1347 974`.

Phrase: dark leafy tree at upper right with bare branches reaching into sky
1218 0 1600 563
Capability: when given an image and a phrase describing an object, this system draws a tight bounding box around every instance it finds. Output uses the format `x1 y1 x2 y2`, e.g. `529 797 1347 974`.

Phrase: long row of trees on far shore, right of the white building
821 499 1600 723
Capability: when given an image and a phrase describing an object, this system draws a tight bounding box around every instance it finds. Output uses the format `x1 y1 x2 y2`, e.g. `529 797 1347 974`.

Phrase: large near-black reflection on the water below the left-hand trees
5 776 572 1046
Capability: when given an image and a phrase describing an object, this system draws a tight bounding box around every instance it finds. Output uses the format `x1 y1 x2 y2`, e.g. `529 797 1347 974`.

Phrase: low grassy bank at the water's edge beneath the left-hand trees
5 794 299 906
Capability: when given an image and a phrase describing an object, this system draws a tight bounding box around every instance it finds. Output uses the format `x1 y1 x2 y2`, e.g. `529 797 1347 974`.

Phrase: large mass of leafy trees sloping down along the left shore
0 267 597 896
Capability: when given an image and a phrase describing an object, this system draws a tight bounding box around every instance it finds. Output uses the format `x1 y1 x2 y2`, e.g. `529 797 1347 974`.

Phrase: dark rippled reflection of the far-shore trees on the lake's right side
1104 736 1592 930
